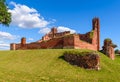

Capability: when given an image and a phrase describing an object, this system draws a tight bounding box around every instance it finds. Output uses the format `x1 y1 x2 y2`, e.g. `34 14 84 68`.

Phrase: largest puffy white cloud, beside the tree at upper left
9 2 49 28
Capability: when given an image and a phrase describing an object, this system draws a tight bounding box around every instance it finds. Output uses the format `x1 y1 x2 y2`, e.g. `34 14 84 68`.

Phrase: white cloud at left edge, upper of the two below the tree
0 31 19 40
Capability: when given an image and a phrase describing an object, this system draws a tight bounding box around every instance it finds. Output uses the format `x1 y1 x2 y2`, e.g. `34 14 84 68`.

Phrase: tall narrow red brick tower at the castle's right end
92 18 100 51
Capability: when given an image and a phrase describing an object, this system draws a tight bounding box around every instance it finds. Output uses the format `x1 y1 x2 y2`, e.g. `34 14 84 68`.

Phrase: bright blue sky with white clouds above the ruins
0 0 120 50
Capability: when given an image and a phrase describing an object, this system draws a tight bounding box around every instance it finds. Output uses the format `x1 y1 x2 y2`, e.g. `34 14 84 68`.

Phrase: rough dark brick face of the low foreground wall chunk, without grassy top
64 53 100 70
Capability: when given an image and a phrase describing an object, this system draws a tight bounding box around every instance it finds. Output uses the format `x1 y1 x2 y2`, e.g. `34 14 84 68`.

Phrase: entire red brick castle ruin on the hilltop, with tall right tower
10 18 100 51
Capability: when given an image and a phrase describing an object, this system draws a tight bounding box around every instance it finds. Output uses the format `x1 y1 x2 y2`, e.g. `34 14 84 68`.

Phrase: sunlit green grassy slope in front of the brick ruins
0 49 120 82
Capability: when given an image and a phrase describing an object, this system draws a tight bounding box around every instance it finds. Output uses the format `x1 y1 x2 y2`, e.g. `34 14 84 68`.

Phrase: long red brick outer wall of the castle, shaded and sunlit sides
11 34 97 50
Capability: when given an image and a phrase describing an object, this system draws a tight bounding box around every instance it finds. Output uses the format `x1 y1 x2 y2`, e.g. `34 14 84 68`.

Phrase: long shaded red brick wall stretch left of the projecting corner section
11 38 63 50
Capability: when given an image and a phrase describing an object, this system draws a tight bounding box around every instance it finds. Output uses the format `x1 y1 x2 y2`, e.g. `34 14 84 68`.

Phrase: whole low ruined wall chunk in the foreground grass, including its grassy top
63 50 100 70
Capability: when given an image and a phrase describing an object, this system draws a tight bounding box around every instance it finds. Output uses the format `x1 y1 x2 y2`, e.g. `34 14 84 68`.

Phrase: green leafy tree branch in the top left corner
0 0 11 26
